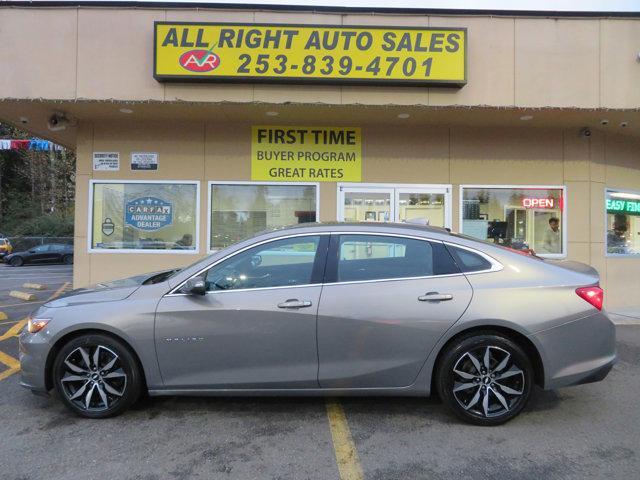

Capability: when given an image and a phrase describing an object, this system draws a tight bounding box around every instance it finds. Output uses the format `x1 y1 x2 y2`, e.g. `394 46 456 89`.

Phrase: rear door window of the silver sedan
337 235 460 282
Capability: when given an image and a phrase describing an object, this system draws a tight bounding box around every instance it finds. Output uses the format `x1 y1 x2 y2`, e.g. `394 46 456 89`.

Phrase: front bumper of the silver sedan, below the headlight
18 331 49 394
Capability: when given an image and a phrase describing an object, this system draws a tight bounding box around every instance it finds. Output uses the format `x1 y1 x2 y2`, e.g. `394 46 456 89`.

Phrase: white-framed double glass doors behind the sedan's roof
338 184 451 228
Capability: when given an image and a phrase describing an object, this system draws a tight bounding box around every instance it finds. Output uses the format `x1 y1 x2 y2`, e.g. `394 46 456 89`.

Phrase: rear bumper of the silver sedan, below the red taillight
530 312 618 390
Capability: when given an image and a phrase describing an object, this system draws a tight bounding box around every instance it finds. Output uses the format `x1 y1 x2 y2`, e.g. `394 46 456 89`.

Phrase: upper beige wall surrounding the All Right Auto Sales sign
0 7 640 108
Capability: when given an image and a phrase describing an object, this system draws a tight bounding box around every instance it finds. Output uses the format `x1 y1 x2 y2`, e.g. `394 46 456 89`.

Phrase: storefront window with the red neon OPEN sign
462 187 566 256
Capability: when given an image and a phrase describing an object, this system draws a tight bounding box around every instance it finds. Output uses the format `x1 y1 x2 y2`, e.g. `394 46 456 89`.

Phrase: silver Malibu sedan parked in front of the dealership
20 223 616 425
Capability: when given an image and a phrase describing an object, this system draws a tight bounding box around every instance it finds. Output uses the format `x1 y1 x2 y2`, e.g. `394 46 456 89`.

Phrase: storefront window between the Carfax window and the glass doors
209 183 318 250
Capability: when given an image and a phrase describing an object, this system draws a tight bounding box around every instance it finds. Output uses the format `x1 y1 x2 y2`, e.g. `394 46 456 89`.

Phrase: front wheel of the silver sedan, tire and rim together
52 334 142 418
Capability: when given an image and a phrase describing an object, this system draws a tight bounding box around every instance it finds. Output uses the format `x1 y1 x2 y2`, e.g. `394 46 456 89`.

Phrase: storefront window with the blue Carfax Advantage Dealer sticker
91 181 198 253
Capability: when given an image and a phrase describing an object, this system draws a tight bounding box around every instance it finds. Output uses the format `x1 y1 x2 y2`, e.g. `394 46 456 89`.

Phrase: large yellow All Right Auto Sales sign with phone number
153 22 467 86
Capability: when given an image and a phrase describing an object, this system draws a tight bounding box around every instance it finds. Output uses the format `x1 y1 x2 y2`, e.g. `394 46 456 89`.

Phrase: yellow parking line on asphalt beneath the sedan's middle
326 400 364 480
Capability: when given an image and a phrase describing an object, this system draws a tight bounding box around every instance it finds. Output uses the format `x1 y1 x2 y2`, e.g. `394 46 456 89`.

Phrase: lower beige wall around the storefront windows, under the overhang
74 121 640 307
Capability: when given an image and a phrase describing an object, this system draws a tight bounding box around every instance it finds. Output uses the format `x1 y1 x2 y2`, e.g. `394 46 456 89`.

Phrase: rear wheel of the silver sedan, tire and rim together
436 332 534 426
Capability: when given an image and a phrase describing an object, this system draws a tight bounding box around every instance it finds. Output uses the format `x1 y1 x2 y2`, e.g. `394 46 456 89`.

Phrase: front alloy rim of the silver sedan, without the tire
60 345 127 412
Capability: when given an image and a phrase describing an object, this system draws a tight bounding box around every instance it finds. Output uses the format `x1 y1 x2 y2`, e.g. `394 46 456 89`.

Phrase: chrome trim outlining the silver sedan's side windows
164 231 504 297
